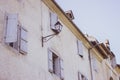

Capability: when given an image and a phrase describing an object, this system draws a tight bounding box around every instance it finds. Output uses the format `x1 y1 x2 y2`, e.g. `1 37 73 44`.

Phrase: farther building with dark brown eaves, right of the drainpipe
86 35 120 80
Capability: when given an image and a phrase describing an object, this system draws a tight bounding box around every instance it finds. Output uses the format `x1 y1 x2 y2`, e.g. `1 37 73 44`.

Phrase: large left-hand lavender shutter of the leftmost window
5 14 18 43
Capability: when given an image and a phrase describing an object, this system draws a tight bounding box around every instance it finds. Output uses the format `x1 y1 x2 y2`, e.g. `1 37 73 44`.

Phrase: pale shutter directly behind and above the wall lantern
50 12 58 29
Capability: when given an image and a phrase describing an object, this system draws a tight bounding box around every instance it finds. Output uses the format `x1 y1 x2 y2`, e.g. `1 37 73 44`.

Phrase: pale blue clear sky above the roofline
56 0 120 64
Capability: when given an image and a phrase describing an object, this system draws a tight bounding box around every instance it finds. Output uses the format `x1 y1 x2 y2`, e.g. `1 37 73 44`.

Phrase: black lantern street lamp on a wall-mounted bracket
42 21 63 47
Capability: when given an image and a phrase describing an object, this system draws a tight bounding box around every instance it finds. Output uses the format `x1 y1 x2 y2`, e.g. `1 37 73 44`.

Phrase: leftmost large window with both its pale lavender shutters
5 14 27 54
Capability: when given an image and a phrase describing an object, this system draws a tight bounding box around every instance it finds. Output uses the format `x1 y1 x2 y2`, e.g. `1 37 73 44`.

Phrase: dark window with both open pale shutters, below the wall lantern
48 50 64 79
